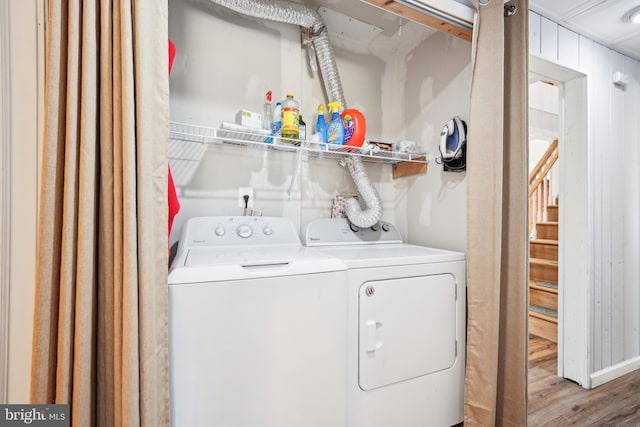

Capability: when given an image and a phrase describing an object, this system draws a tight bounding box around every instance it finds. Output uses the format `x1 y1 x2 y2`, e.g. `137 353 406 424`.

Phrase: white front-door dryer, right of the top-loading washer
303 218 466 427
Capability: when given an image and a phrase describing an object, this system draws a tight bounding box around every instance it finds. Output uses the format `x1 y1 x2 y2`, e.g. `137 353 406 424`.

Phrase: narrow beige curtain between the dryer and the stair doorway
465 0 528 427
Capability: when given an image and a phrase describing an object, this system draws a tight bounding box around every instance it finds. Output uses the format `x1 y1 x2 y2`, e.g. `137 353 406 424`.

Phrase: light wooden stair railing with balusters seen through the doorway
529 139 558 236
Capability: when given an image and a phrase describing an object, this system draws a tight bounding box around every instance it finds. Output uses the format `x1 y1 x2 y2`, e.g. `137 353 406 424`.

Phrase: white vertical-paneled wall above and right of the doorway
529 12 640 386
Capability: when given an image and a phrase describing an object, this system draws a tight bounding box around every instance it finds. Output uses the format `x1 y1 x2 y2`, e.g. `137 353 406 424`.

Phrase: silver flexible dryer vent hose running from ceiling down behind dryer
211 0 382 228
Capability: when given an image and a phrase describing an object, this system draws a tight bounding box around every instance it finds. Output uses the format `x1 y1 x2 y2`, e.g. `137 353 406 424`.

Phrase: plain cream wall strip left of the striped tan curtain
0 0 44 403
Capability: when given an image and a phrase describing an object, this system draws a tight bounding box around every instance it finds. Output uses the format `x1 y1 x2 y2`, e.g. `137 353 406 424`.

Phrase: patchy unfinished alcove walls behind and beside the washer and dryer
169 1 471 254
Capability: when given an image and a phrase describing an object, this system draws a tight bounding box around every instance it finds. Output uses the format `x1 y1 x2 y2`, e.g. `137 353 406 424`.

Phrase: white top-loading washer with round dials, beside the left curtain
169 217 347 427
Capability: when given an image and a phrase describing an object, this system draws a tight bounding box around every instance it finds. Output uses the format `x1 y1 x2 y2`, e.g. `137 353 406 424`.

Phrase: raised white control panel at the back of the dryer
302 218 402 246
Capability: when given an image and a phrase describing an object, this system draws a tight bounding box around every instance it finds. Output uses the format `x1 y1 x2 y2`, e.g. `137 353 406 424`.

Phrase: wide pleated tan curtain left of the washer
31 0 169 427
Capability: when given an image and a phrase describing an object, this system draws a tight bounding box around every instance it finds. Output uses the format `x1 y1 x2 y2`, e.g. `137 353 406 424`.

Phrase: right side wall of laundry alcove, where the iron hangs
406 33 471 252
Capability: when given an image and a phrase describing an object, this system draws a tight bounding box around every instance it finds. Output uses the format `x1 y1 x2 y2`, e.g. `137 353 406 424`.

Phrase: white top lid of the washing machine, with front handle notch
169 245 347 285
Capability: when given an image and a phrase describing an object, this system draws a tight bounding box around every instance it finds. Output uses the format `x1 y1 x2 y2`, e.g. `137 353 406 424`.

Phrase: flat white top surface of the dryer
322 243 465 268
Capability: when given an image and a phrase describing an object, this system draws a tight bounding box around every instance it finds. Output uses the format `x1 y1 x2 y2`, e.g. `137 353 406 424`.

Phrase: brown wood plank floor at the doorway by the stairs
527 335 640 427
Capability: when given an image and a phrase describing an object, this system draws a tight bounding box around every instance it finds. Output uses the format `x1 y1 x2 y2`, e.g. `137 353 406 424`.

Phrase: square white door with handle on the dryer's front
358 274 456 390
